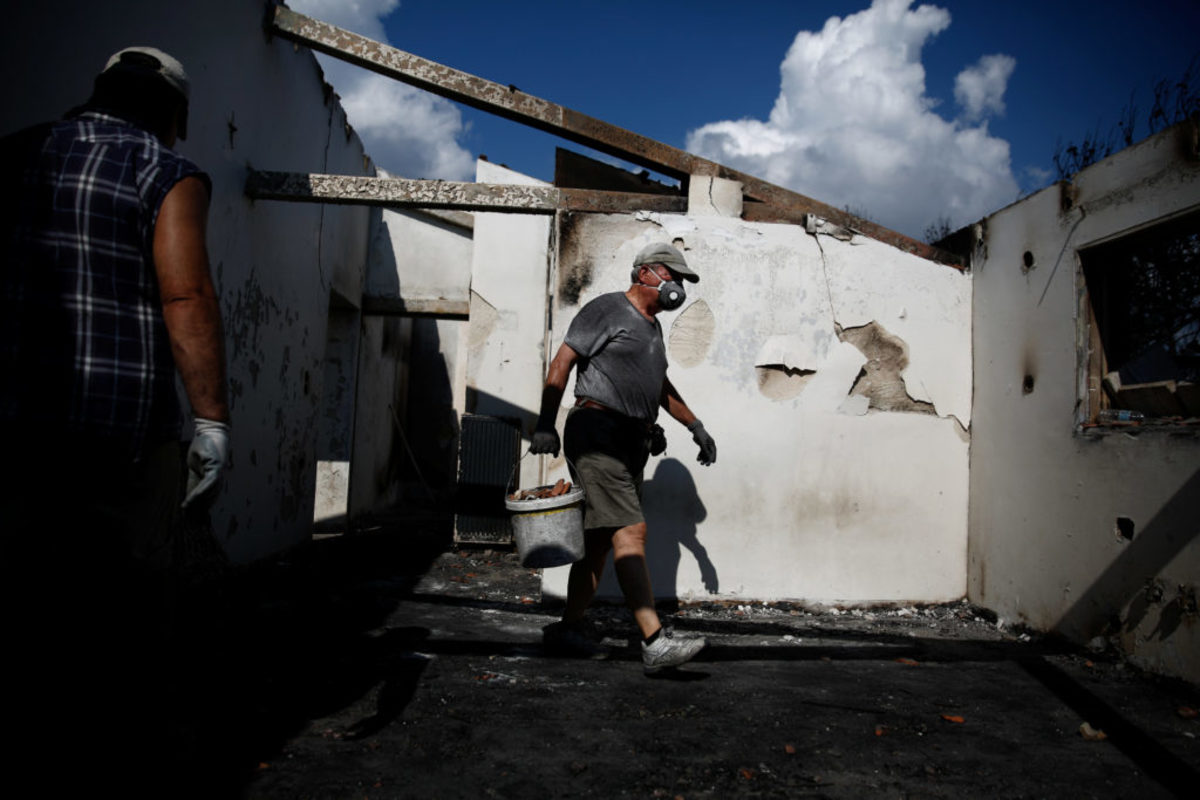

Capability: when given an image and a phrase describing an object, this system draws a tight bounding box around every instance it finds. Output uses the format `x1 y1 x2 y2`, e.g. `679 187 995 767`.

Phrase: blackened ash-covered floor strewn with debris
171 527 1200 800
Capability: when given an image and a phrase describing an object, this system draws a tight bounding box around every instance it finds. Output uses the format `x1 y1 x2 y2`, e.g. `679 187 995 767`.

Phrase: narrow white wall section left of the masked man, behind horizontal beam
466 161 551 487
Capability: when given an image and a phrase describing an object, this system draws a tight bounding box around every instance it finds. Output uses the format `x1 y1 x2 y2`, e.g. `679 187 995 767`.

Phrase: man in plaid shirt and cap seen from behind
0 47 229 786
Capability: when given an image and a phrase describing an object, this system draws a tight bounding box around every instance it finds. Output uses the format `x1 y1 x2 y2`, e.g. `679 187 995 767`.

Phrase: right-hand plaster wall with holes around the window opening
970 126 1200 681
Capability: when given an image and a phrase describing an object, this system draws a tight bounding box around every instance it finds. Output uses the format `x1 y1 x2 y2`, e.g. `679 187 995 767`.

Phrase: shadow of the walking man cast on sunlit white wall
599 458 720 599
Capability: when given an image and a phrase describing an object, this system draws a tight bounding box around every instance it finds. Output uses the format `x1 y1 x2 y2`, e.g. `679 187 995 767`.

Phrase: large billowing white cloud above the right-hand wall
688 0 1018 237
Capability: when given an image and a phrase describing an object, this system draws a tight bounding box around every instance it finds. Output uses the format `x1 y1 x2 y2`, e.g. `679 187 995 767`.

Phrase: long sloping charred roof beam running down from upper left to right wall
266 5 964 266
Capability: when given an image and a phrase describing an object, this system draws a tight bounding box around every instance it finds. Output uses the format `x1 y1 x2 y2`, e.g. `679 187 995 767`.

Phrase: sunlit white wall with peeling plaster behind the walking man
544 213 971 603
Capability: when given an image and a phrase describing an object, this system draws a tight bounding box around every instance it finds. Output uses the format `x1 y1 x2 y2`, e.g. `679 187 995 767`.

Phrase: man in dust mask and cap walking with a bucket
530 243 716 674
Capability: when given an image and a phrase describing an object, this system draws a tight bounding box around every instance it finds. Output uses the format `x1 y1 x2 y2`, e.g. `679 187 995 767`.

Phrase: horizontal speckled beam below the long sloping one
246 169 688 215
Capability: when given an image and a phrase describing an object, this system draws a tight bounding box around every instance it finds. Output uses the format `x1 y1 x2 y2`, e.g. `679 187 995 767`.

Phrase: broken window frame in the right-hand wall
1075 206 1200 432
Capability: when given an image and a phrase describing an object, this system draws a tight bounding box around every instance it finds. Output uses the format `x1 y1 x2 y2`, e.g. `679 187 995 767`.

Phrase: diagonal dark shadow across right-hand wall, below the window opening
1054 470 1200 640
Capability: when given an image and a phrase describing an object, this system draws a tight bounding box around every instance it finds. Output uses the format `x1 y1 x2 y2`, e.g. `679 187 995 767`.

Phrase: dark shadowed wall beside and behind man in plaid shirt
0 0 367 561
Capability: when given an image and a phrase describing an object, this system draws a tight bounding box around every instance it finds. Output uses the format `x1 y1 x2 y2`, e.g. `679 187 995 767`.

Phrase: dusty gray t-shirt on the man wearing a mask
563 291 667 422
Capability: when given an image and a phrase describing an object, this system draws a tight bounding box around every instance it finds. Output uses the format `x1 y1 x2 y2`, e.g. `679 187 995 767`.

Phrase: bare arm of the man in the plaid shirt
154 178 229 422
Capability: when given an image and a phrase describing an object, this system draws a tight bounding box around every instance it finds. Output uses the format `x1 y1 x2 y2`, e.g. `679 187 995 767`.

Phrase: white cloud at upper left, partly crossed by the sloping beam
288 0 475 180
